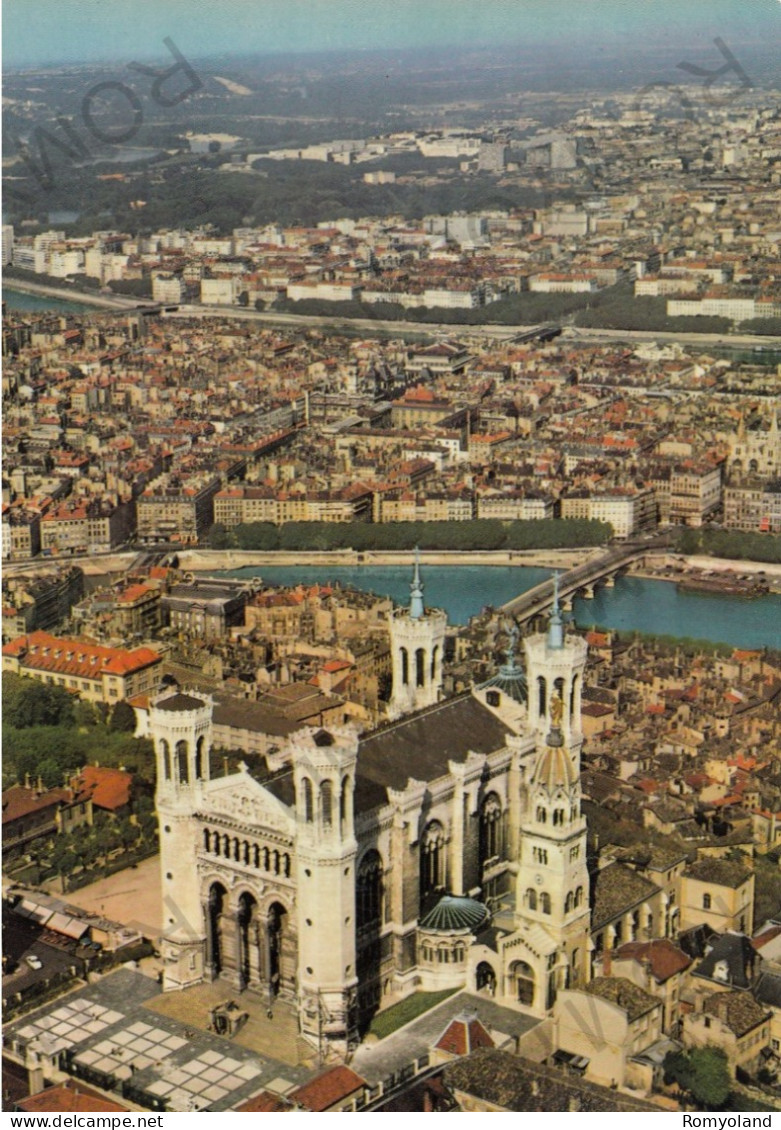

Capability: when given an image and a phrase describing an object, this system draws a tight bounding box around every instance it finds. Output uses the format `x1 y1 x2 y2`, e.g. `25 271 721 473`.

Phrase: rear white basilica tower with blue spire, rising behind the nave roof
388 549 448 718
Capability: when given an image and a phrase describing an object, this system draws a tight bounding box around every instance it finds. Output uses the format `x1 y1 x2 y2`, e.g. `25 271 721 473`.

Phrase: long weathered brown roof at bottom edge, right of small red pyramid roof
444 1048 661 1113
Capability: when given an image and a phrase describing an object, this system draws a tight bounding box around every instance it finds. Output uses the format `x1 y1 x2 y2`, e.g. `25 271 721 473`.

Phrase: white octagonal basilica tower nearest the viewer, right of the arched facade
292 727 358 1054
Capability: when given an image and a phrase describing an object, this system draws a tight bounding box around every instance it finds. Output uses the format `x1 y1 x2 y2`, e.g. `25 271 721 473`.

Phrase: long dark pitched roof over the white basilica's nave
358 694 512 790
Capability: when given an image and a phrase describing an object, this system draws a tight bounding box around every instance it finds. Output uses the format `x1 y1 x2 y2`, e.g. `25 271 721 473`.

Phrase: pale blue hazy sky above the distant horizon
2 0 781 69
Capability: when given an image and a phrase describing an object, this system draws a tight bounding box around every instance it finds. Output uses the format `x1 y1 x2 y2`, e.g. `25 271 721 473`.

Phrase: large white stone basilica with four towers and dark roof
149 562 590 1052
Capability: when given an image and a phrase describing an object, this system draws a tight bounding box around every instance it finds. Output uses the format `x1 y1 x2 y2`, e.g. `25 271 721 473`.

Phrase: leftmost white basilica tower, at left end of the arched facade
149 693 212 990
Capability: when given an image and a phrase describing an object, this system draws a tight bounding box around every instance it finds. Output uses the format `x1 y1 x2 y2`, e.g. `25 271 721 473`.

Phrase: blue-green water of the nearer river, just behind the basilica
221 565 781 649
